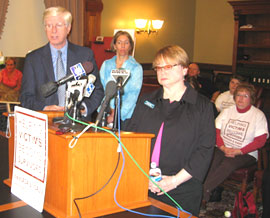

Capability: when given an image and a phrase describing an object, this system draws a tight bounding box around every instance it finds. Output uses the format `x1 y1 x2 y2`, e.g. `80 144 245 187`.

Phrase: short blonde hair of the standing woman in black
153 45 189 68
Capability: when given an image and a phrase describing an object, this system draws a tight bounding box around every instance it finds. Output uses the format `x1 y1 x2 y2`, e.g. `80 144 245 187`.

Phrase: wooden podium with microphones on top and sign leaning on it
5 112 154 218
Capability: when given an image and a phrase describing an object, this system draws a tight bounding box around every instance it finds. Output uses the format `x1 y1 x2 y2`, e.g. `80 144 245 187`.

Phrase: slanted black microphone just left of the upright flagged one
96 81 116 125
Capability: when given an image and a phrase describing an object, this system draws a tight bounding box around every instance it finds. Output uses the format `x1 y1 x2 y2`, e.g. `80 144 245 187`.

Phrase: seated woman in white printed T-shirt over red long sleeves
203 84 269 202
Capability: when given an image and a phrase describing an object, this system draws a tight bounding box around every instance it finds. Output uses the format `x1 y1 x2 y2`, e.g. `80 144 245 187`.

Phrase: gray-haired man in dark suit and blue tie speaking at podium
20 7 104 119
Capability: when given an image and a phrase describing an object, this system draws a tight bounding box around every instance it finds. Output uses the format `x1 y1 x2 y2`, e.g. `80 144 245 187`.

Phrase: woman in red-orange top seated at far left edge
0 58 22 91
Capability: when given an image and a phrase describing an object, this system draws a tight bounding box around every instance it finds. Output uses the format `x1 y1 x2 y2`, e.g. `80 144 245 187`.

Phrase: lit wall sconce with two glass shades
135 19 164 35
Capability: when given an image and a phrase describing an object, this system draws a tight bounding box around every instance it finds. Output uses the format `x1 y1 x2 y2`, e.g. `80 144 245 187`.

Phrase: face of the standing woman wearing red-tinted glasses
155 58 188 88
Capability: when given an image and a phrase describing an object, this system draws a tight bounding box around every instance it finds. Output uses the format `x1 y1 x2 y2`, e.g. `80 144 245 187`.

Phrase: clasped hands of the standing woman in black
149 176 177 195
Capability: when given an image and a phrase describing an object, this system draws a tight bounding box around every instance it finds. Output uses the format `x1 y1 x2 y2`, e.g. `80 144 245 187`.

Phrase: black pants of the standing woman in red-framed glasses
148 178 203 216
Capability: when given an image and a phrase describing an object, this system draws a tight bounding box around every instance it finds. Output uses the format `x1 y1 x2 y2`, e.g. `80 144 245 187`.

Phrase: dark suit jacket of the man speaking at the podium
20 42 104 118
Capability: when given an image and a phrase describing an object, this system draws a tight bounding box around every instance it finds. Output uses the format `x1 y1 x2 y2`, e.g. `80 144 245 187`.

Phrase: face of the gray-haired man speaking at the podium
45 15 71 49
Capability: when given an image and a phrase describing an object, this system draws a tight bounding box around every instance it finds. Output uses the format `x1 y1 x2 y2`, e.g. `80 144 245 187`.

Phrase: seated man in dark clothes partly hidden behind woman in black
188 63 220 102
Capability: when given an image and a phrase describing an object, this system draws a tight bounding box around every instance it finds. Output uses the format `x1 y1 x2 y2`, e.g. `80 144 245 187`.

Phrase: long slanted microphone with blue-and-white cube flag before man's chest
40 61 94 98
